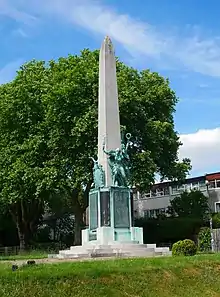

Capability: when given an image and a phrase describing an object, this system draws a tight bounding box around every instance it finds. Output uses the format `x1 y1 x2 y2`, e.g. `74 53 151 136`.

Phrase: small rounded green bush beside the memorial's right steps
172 239 197 256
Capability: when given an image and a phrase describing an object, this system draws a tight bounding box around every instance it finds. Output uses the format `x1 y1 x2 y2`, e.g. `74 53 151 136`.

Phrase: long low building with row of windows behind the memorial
133 172 220 218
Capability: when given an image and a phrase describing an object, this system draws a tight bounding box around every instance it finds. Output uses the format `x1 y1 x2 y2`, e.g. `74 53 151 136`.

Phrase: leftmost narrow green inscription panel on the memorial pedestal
89 192 98 230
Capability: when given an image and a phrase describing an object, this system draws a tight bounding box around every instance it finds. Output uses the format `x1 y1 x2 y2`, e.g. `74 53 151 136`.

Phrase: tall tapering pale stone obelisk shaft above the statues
98 36 121 187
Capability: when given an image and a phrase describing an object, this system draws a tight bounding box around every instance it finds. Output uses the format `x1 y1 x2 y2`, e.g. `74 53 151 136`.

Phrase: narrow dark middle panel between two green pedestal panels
100 191 111 227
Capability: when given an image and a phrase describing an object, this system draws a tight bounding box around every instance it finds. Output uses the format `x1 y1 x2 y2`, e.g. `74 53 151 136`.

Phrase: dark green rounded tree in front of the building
168 190 209 220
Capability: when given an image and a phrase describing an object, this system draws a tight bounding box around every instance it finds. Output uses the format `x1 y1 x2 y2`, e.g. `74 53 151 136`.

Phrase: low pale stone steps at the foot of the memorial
48 242 172 259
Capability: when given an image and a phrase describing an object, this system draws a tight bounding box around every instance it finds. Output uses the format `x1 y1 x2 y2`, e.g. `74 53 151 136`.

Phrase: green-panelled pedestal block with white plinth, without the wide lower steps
82 187 143 245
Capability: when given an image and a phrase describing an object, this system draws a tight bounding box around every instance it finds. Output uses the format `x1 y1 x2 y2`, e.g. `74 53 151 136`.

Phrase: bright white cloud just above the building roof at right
180 128 220 174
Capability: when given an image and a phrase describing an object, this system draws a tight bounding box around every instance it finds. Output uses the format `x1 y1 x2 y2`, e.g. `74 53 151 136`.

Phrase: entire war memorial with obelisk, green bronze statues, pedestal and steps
51 37 171 259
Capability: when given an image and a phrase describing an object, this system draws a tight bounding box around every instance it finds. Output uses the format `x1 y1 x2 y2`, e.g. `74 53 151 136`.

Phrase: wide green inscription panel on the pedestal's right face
113 190 130 228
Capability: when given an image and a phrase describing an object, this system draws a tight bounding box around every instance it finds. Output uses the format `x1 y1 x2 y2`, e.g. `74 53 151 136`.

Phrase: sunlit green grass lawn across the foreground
0 254 220 297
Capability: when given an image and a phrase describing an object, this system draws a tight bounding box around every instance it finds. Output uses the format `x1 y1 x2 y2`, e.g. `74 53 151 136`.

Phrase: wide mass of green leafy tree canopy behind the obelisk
0 50 190 243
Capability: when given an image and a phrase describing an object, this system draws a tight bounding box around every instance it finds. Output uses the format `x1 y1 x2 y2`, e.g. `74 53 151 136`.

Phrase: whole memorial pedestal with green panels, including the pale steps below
50 187 171 259
